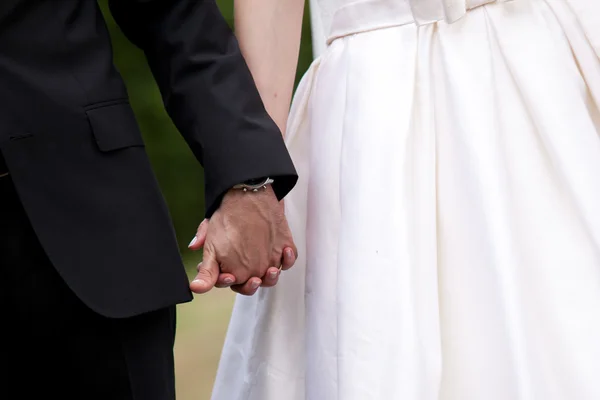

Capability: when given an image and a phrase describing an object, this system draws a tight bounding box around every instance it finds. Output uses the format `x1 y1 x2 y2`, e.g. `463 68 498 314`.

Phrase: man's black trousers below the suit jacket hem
0 176 175 400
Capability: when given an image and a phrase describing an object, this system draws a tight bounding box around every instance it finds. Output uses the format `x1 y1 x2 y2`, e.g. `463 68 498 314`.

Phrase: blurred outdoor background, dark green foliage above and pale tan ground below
99 0 312 400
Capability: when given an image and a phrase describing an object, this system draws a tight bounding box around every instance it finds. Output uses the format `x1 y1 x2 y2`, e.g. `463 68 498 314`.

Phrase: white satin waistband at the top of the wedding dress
327 0 513 45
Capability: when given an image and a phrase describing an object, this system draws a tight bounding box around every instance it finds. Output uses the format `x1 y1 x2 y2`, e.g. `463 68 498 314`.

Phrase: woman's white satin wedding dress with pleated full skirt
213 0 600 400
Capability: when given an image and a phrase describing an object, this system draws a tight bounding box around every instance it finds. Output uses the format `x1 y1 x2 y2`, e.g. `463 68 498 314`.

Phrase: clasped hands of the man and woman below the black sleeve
190 187 297 295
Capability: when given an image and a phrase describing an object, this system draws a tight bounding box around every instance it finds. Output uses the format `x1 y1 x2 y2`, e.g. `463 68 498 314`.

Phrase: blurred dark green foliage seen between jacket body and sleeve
98 0 312 257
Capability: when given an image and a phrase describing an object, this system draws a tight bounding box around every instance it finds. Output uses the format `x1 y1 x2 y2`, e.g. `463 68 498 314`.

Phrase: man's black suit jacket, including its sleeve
0 0 296 317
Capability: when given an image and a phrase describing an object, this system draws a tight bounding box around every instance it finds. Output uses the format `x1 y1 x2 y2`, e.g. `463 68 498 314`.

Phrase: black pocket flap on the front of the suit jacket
85 101 144 151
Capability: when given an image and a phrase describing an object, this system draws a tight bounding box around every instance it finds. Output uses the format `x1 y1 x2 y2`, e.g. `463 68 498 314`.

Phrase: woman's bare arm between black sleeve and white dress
234 0 304 134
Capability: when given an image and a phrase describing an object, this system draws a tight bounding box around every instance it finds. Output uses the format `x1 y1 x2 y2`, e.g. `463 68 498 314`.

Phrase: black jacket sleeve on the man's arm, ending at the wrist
110 0 297 217
